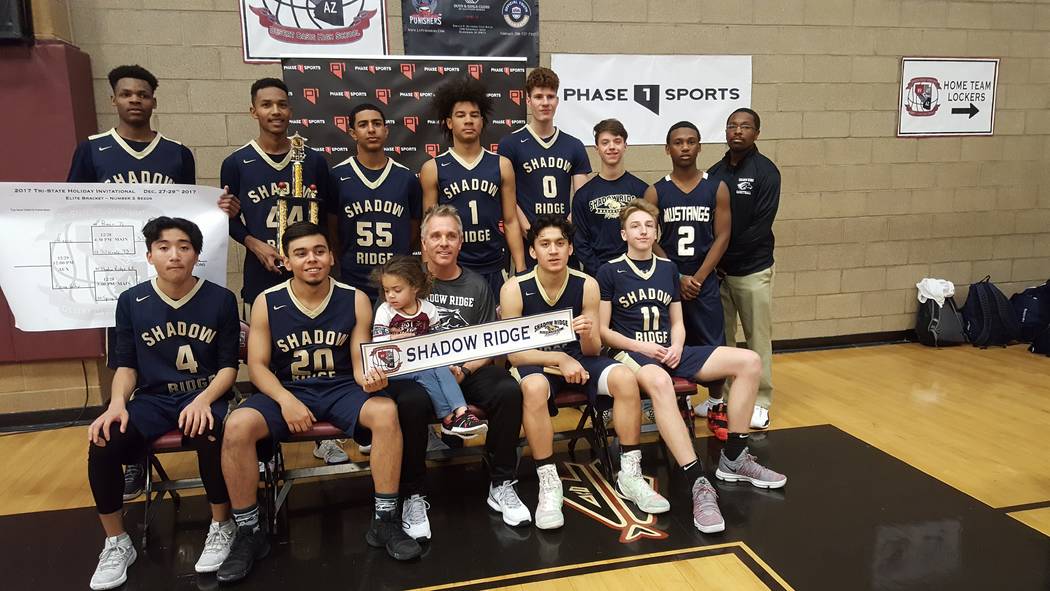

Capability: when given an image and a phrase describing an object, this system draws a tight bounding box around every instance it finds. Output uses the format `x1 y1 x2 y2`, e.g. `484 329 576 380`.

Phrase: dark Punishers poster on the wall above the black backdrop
401 0 540 67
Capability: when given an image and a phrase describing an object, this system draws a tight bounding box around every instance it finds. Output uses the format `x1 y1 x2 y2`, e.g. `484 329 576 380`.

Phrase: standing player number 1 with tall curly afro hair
419 78 525 294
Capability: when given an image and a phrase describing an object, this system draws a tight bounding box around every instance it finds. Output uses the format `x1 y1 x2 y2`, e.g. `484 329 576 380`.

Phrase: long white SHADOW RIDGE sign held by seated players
361 308 576 377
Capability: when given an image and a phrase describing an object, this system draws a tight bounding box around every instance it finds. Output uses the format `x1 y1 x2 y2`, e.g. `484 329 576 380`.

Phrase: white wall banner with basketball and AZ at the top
239 0 386 62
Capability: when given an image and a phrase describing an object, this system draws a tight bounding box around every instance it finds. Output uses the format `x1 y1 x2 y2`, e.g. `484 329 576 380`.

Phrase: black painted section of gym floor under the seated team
8 426 1050 591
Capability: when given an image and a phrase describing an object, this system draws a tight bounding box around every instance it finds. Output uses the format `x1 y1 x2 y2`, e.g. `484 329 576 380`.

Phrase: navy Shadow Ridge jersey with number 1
434 150 506 274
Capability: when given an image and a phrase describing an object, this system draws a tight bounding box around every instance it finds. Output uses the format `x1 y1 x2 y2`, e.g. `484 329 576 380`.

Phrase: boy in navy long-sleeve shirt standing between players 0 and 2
572 119 649 277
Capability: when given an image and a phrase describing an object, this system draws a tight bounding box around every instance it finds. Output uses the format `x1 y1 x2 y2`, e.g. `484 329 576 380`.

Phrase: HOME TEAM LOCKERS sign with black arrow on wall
897 58 999 135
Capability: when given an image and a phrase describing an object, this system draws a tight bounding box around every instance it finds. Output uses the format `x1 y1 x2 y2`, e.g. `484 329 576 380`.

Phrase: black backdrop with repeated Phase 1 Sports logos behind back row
282 57 525 173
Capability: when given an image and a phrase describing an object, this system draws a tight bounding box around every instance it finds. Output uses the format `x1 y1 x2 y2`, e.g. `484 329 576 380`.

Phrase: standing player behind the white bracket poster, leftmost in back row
66 65 240 501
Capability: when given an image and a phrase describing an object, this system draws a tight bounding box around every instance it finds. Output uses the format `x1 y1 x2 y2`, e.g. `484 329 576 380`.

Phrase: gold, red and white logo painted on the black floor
562 460 668 544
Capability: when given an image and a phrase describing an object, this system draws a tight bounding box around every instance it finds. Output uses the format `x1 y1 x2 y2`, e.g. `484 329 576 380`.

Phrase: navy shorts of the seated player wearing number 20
239 377 383 445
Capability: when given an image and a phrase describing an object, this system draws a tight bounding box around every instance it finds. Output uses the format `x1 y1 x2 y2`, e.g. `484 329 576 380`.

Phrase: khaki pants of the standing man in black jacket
721 267 774 408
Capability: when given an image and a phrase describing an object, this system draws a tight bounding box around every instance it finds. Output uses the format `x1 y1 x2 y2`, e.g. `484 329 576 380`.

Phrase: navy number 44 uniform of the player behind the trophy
219 140 329 303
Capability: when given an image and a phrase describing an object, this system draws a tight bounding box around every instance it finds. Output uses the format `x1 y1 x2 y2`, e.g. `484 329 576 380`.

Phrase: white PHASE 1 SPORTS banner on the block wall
550 54 751 146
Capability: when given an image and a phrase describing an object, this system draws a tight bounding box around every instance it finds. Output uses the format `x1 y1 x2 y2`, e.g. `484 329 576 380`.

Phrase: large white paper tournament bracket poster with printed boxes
0 183 229 332
